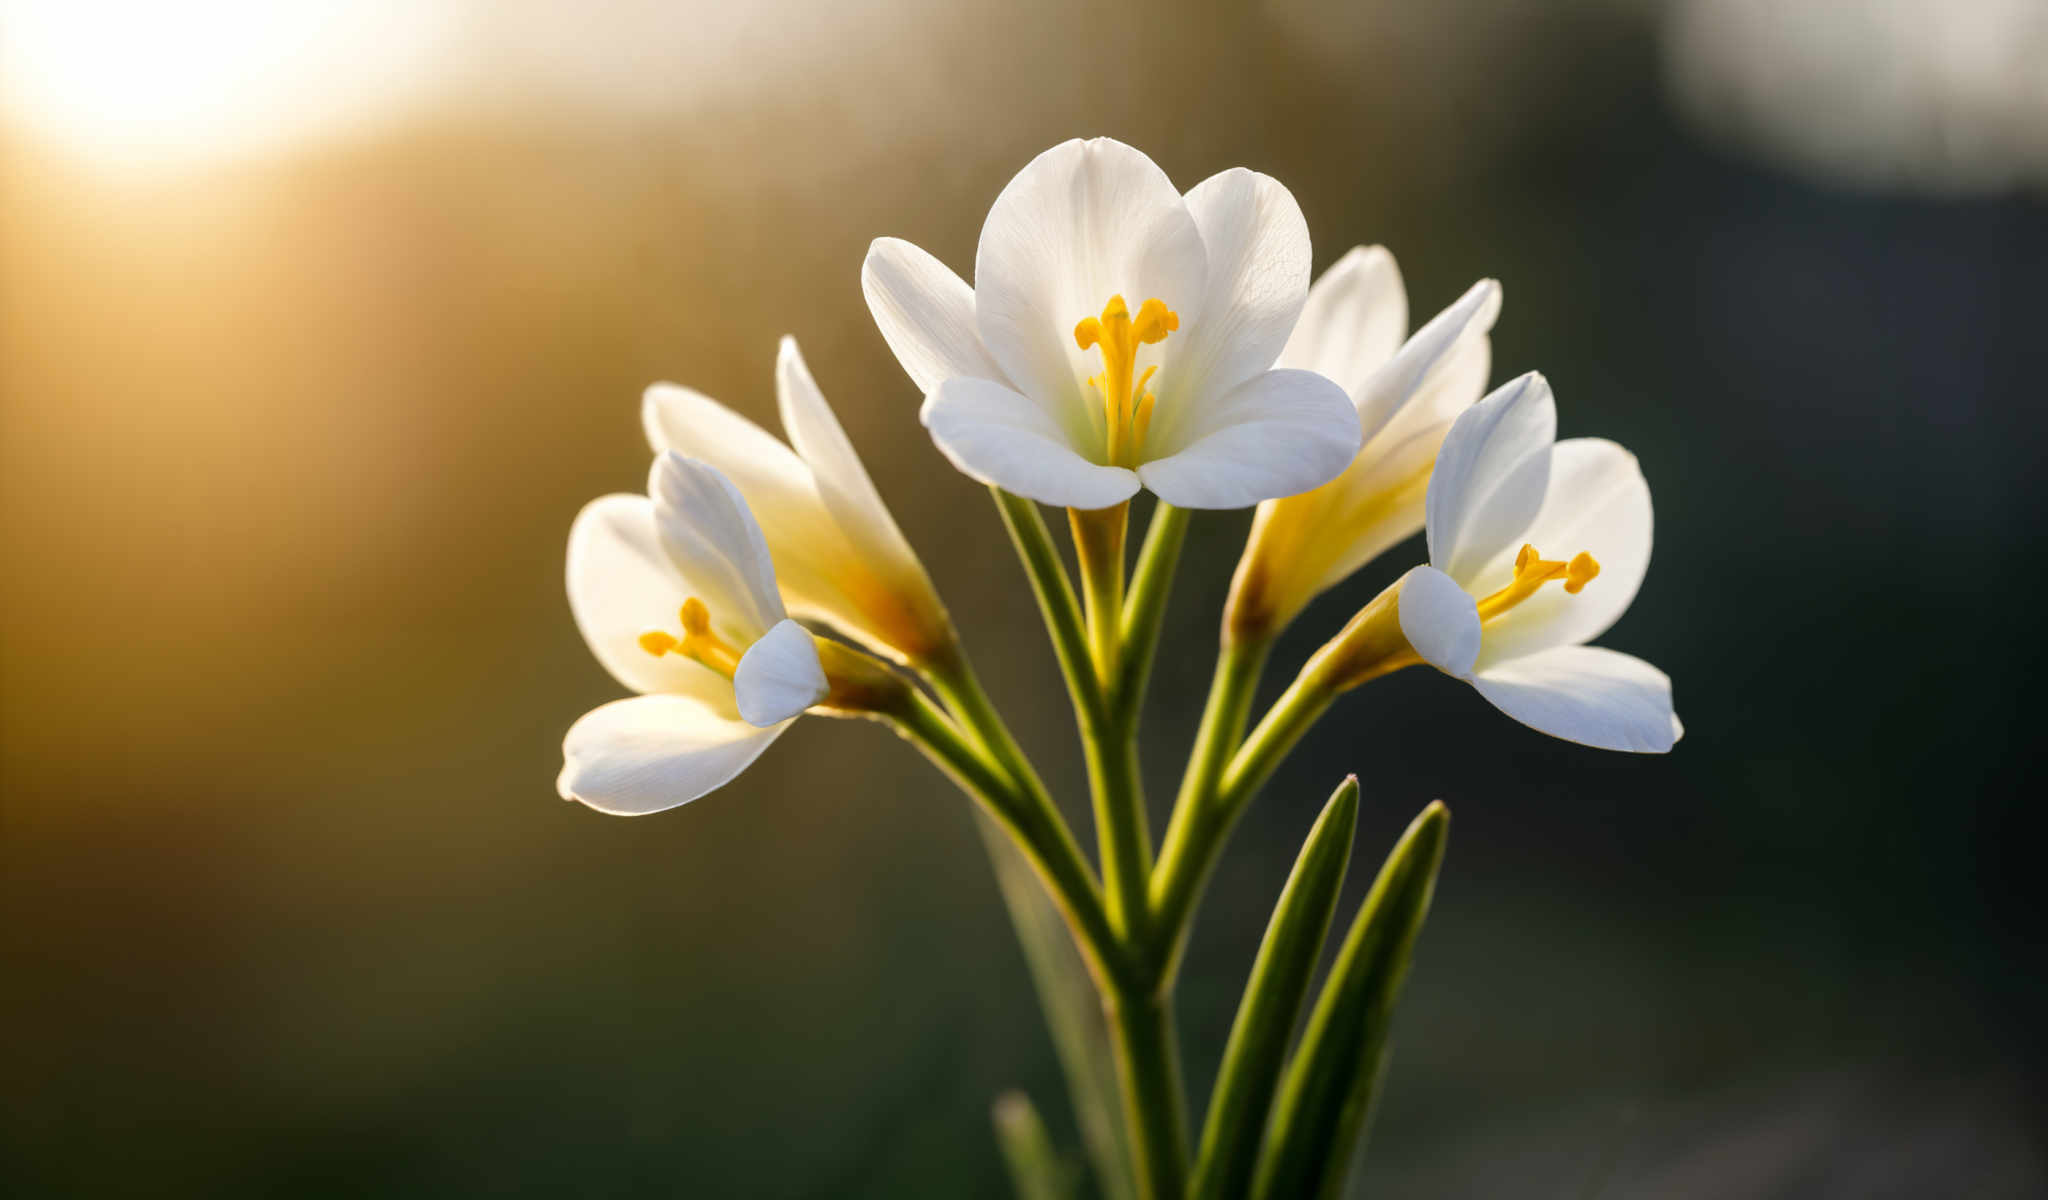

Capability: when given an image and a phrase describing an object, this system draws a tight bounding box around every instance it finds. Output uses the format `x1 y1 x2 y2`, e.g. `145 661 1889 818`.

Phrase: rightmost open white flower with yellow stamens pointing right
1399 373 1683 752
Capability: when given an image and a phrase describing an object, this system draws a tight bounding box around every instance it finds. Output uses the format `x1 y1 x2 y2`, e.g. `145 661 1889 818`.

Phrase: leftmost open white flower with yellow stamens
557 453 829 817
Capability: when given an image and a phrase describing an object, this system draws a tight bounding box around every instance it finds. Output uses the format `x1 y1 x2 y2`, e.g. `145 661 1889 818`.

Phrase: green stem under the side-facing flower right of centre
1151 639 1272 979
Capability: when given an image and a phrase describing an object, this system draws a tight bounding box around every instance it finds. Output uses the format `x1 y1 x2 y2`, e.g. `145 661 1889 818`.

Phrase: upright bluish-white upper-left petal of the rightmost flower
1425 371 1556 584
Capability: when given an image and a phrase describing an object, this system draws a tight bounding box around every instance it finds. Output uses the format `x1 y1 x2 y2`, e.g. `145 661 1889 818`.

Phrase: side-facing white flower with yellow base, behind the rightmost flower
1225 246 1501 635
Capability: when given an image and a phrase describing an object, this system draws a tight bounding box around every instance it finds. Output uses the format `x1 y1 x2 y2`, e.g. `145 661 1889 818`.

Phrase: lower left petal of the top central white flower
920 379 1139 508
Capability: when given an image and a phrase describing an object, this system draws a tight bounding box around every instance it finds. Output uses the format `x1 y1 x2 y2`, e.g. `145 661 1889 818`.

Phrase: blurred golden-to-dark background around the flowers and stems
0 0 2048 1198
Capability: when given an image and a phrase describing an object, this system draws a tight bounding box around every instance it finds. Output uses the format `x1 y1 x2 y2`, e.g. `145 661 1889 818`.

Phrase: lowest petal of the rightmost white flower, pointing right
1473 645 1683 754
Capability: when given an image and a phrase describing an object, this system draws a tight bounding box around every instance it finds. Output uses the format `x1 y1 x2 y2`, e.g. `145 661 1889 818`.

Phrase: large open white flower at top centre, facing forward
860 137 1358 508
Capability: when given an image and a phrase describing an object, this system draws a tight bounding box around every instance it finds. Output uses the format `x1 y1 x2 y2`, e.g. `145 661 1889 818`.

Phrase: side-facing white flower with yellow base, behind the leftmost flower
641 338 954 663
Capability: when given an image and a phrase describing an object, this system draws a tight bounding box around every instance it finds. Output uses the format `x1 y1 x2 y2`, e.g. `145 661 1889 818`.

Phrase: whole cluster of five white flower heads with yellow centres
559 139 1679 813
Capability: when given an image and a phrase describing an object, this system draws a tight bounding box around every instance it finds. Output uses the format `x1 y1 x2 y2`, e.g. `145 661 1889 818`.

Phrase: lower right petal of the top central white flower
1139 371 1358 508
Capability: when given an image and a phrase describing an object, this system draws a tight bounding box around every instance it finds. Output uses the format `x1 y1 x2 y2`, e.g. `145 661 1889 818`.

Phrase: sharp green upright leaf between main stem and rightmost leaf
1190 776 1358 1200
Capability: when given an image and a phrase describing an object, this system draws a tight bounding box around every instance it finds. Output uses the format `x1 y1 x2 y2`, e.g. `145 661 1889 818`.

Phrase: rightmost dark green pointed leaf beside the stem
1253 801 1450 1200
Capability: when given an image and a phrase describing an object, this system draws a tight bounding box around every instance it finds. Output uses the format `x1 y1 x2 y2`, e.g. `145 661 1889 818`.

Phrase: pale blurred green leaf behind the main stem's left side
975 809 1137 1200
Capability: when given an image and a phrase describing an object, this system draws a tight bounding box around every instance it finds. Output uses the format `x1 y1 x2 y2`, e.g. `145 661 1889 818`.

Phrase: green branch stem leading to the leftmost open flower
885 692 1128 987
